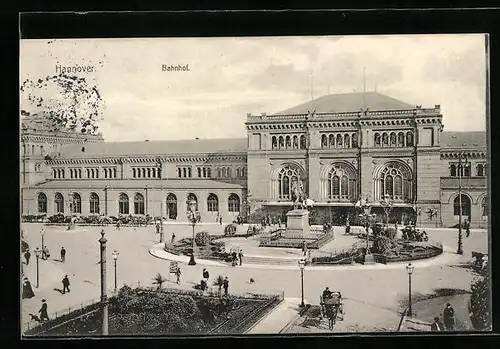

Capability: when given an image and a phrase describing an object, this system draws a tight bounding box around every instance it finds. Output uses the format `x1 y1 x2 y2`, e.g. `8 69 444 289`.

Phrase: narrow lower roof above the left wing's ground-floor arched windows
35 179 243 191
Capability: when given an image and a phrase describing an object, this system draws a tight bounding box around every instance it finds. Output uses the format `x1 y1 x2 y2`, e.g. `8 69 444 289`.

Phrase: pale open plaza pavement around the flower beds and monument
22 224 488 334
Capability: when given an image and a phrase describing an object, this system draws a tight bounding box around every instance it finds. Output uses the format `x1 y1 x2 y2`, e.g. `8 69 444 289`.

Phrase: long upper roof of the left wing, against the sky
59 138 247 158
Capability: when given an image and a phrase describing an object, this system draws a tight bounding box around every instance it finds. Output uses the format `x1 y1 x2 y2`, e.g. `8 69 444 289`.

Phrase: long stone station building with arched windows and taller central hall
21 92 488 227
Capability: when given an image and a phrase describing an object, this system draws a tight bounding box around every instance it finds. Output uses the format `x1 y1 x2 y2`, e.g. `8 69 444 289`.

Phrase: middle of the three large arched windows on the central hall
323 163 357 201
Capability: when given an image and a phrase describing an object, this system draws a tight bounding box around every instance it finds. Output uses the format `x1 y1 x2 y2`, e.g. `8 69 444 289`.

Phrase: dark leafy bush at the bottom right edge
470 274 491 331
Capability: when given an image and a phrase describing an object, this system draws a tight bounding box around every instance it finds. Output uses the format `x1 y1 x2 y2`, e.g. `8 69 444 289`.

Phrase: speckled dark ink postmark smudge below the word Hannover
20 73 104 134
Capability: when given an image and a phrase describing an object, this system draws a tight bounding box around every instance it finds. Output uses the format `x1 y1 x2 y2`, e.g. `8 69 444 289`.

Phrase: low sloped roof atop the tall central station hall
274 92 415 115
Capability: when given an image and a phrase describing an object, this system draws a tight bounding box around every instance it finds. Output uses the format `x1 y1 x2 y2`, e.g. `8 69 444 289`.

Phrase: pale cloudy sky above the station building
20 34 486 141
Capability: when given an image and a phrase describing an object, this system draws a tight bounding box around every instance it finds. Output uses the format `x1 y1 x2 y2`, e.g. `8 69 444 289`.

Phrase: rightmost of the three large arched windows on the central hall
379 162 412 202
